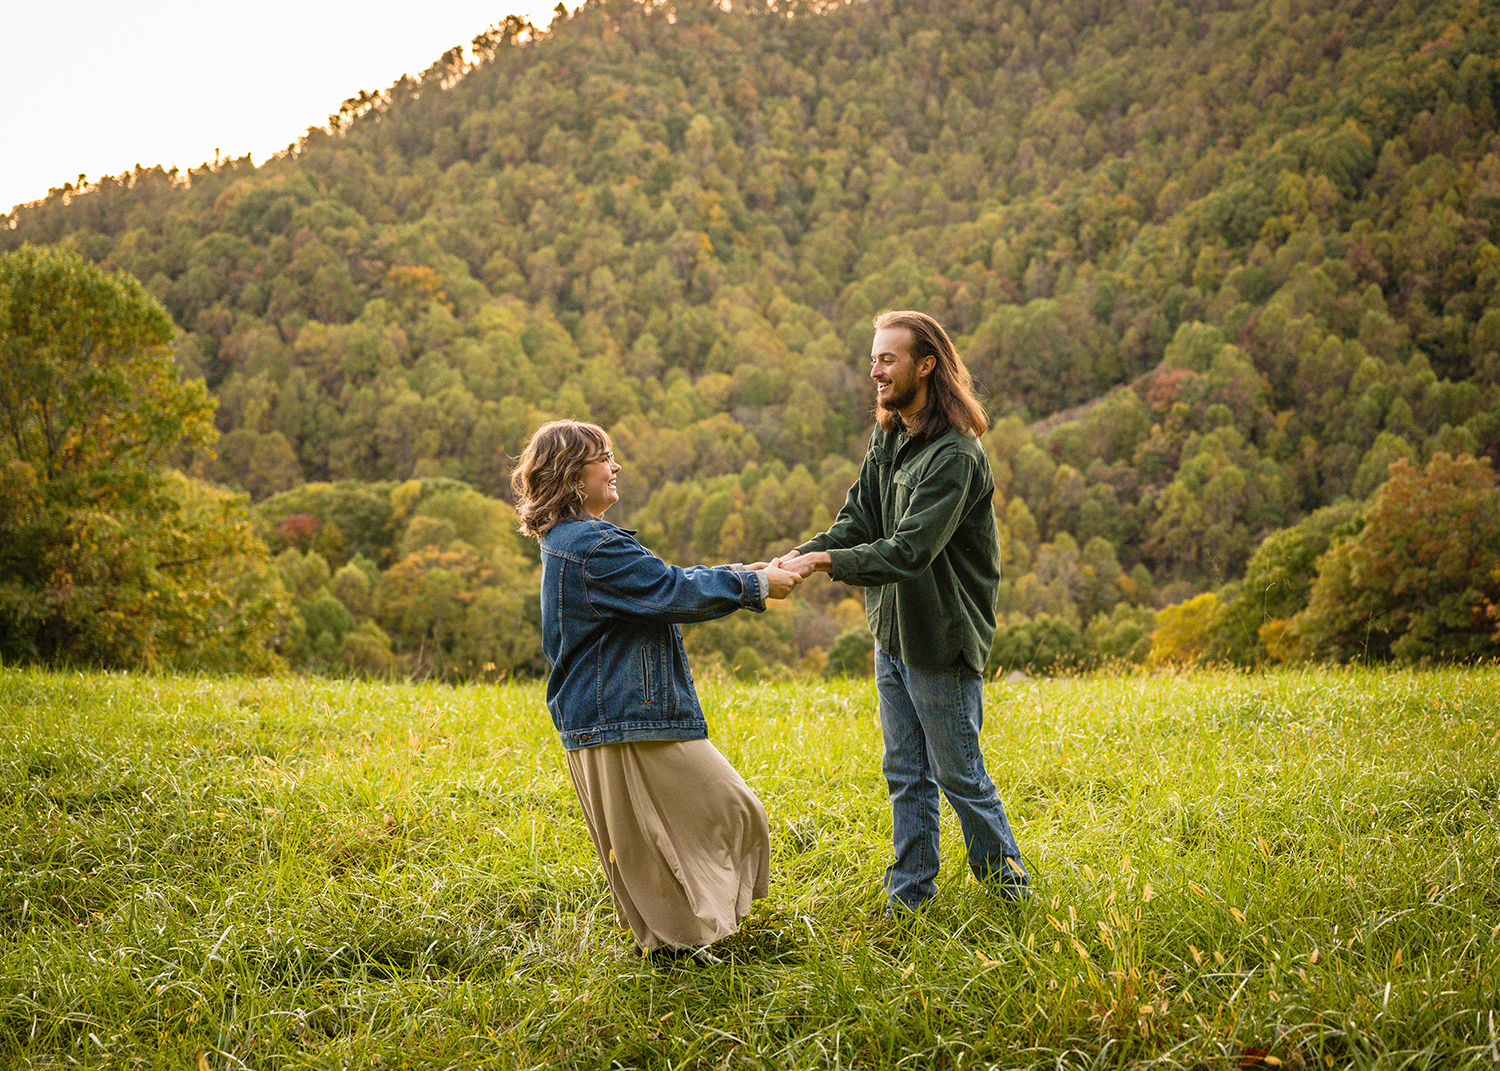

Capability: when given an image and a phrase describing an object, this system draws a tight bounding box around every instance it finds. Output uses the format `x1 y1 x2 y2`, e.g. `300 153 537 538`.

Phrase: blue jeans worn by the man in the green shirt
875 645 1029 911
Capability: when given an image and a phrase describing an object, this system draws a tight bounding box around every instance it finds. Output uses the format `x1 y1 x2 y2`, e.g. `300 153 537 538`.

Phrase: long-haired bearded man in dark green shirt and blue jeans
780 312 1029 915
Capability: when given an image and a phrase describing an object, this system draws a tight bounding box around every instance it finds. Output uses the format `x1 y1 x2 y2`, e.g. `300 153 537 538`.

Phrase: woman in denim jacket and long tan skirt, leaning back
510 420 800 954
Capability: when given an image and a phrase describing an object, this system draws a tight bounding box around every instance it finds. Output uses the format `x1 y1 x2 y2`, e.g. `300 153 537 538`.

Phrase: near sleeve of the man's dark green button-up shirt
828 452 980 587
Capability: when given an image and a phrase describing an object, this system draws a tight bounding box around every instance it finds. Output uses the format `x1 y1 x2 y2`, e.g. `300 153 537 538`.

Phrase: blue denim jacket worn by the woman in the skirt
542 518 765 750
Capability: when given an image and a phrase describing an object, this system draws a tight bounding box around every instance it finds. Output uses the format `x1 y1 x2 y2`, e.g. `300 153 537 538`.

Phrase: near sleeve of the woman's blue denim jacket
582 528 765 624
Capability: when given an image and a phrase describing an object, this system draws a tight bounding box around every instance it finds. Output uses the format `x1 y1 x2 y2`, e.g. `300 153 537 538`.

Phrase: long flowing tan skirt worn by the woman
567 740 771 953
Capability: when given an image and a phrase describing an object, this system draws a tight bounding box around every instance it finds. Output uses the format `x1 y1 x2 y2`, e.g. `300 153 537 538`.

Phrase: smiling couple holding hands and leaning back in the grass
512 312 1028 954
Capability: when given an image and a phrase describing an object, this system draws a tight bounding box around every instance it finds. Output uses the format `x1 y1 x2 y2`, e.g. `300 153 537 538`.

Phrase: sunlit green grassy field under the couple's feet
0 669 1500 1071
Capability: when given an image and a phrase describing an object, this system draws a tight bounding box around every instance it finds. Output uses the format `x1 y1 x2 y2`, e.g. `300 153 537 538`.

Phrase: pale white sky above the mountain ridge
0 0 578 213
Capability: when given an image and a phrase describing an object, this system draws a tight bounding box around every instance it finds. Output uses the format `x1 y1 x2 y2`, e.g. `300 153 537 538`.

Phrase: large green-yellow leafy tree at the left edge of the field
0 246 282 669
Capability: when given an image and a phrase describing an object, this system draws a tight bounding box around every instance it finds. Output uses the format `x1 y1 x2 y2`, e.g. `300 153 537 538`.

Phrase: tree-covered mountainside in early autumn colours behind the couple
0 0 1500 669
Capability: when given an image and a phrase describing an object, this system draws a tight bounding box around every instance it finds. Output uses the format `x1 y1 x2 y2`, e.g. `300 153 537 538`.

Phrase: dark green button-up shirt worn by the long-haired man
798 428 1001 674
